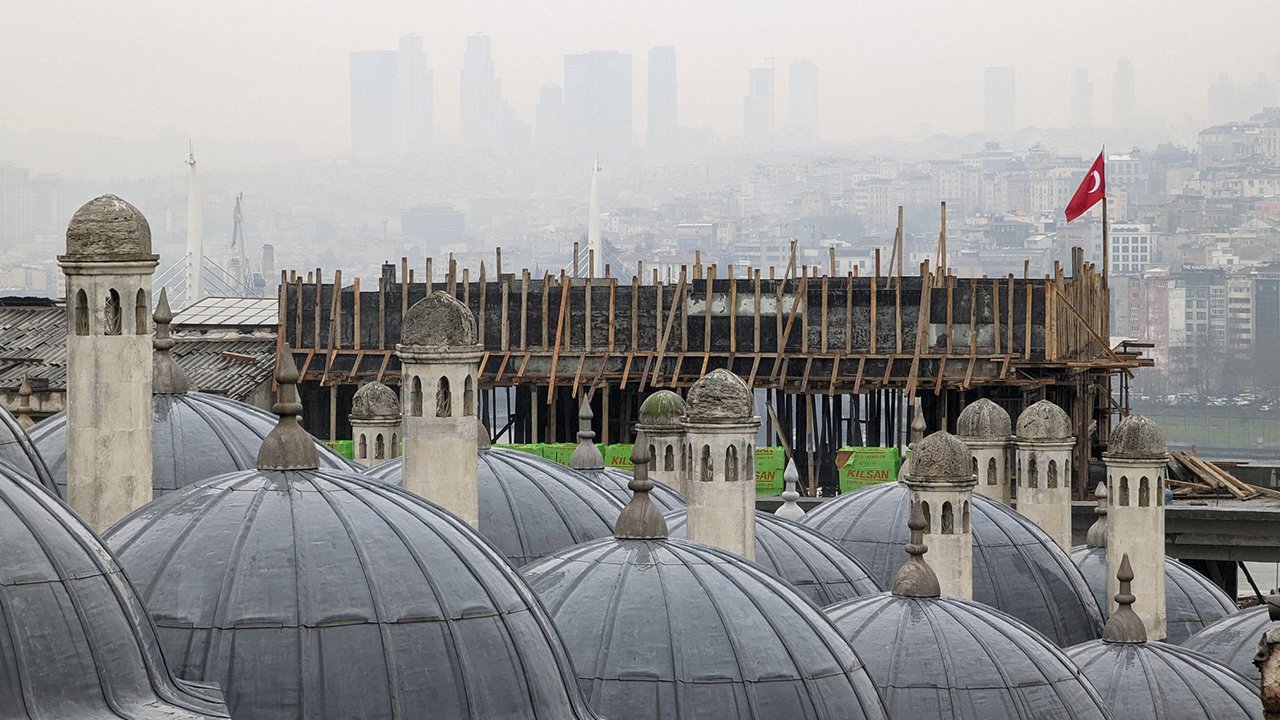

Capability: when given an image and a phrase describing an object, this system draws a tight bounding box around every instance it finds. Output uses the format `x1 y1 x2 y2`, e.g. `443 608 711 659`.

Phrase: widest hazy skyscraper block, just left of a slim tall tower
564 53 631 155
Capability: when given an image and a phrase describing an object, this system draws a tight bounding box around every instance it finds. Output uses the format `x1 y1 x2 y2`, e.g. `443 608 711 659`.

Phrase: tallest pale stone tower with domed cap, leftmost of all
58 195 159 532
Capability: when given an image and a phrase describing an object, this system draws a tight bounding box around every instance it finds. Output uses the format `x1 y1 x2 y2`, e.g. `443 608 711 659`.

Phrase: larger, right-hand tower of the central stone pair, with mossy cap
681 369 760 560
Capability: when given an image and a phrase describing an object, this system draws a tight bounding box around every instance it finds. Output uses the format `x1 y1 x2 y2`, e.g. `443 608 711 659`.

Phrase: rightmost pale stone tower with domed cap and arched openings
1102 415 1169 641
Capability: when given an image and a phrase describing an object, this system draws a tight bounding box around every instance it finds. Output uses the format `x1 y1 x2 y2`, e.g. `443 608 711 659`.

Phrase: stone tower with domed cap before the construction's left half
396 291 484 528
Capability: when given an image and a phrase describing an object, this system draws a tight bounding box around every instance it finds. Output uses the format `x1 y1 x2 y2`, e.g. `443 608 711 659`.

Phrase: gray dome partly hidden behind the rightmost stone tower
1071 546 1236 644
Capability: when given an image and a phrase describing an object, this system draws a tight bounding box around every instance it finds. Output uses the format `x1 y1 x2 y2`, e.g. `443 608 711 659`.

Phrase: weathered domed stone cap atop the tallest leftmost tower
67 195 155 261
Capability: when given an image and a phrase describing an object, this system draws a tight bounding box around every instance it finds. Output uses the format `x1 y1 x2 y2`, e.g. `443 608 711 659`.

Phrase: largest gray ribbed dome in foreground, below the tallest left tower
106 470 591 720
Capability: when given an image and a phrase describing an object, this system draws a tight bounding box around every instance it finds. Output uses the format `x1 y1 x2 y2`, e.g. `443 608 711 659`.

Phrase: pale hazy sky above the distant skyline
0 0 1280 155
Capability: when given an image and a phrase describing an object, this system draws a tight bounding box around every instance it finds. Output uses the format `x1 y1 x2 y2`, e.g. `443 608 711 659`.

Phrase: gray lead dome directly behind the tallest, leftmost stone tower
31 392 352 497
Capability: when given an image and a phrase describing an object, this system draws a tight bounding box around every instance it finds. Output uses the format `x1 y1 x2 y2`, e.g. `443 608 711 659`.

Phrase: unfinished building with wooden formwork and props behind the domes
276 229 1151 497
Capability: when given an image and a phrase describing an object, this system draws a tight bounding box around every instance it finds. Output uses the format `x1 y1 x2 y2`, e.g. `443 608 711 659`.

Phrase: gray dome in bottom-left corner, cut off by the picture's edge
0 456 227 720
